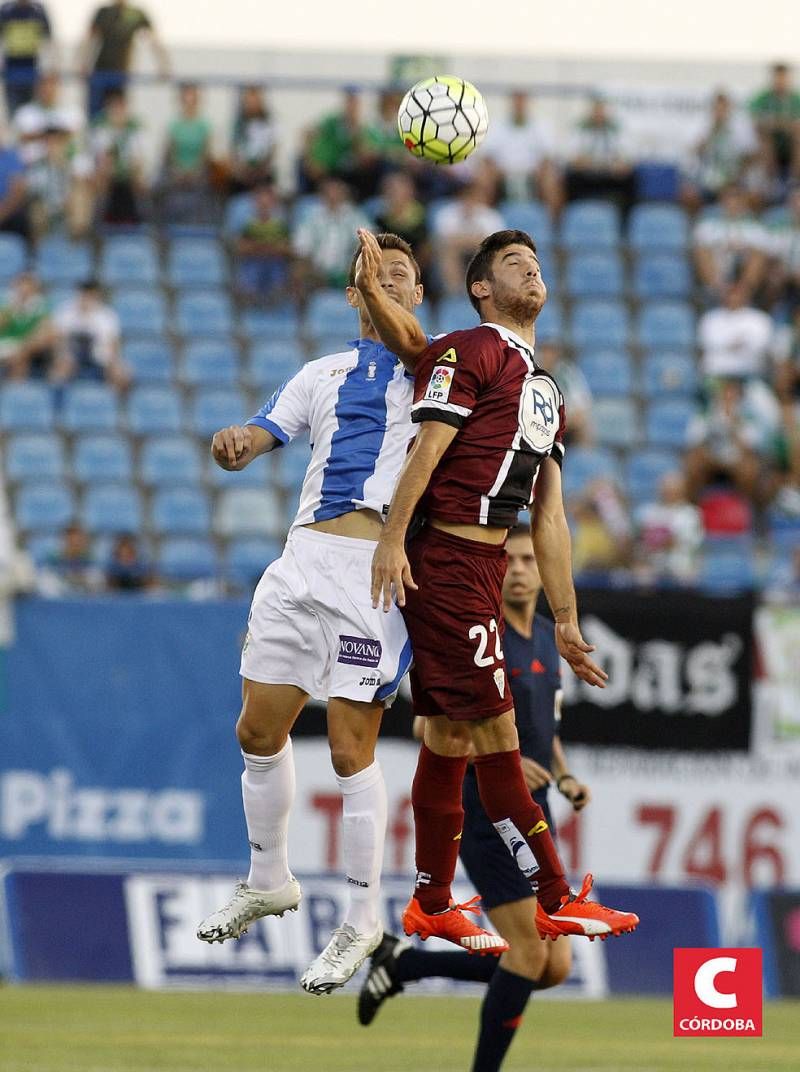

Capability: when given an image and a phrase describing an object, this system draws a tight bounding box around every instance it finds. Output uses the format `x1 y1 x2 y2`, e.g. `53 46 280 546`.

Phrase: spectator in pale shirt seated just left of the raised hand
292 178 371 298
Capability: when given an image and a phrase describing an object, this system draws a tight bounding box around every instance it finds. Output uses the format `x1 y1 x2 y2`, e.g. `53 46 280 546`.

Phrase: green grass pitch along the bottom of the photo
0 986 800 1072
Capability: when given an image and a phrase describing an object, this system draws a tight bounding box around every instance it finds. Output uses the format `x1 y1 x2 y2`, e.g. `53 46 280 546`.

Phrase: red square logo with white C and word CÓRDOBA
672 949 761 1038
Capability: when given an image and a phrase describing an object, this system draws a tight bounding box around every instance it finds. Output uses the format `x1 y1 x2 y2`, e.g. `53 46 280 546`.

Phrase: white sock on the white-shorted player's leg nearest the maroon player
336 761 388 934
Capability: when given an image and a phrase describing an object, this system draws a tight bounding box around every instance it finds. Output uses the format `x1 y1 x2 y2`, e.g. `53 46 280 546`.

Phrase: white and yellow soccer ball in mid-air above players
397 74 489 164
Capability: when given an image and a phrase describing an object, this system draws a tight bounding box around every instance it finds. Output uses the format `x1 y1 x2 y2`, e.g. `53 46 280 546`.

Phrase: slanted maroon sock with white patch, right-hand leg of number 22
475 748 569 912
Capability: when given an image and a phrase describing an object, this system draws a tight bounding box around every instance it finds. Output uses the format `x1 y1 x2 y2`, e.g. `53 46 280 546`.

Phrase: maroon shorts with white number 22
403 525 514 721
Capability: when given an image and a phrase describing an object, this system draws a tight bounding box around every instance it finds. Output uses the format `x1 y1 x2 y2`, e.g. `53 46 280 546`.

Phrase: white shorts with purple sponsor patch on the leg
239 527 411 708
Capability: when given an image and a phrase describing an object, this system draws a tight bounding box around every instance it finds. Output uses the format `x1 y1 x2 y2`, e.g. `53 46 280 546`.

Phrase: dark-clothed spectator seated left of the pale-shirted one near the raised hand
234 182 292 303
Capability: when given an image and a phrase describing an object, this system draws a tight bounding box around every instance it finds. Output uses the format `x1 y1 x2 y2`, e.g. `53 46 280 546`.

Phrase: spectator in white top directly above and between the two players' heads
433 182 505 295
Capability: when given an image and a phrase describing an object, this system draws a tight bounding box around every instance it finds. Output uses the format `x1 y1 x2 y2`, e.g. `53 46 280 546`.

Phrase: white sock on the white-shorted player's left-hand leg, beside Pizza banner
241 738 295 890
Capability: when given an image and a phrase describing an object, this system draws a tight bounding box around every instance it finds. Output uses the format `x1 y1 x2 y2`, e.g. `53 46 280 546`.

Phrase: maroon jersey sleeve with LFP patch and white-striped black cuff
411 330 491 428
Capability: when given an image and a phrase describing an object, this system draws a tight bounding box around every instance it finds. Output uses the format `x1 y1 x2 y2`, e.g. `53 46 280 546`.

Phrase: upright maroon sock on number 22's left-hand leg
411 745 466 912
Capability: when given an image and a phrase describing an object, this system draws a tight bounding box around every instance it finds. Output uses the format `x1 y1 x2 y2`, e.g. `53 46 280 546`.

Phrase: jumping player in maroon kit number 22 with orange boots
361 230 639 944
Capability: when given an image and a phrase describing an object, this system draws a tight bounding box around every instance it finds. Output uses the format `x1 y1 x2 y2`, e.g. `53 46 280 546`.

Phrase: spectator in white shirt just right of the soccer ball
482 89 564 215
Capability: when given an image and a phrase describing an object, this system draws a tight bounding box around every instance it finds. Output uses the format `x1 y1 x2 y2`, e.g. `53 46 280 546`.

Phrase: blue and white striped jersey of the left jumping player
248 339 416 528
